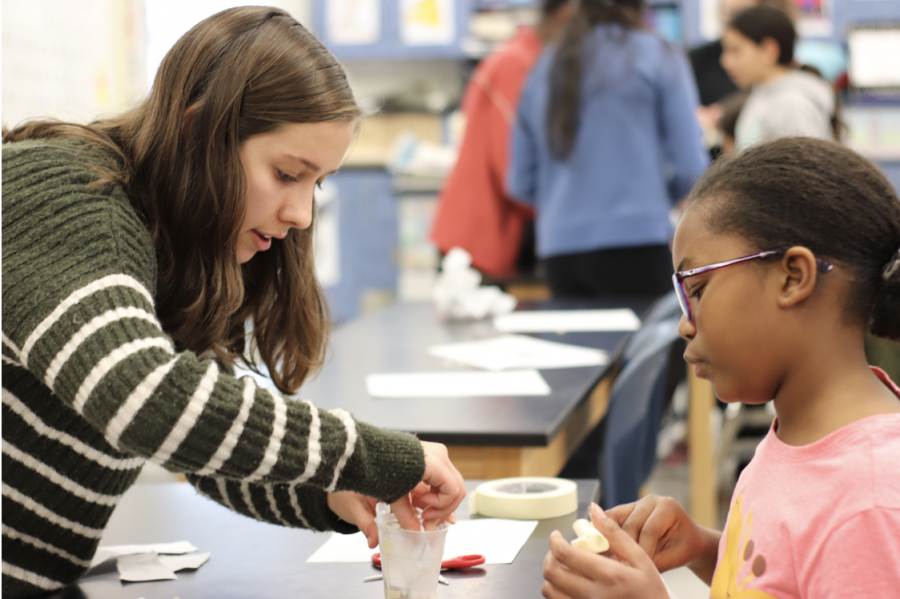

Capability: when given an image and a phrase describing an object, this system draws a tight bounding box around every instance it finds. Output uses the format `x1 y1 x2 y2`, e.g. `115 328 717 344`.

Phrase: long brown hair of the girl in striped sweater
3 7 361 393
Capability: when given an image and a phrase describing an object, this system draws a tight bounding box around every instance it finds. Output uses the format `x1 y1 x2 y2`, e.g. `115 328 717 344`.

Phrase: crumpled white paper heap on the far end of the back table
432 248 516 320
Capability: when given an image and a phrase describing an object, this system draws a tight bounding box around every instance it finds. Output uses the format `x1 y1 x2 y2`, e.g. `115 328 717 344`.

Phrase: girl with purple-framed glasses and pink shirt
544 137 900 599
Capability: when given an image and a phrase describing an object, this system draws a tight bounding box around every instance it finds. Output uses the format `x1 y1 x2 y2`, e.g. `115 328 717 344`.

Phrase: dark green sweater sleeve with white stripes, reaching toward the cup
3 144 424 528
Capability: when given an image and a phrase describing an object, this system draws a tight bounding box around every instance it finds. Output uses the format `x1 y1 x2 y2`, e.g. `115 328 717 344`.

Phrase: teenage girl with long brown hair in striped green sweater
3 7 465 597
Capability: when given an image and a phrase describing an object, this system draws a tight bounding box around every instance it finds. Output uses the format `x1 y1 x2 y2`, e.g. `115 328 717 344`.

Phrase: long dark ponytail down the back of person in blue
547 0 644 159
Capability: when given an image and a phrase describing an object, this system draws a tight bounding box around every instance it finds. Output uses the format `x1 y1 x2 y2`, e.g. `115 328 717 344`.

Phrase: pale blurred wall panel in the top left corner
2 0 146 126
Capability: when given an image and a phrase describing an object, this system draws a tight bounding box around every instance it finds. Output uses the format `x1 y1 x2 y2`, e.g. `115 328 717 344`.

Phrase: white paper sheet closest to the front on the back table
366 370 550 398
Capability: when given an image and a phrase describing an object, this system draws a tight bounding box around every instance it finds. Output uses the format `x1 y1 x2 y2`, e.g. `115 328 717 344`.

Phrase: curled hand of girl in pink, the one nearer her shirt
606 495 721 582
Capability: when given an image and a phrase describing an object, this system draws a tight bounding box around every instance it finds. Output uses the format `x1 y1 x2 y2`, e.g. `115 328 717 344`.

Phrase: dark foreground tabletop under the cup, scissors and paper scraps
44 480 599 599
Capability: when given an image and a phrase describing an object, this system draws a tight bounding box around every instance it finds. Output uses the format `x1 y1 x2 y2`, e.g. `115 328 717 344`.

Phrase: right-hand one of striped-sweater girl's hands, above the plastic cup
391 441 466 530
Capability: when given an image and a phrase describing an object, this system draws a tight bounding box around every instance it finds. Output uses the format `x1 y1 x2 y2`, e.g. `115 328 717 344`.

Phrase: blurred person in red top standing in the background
431 0 574 277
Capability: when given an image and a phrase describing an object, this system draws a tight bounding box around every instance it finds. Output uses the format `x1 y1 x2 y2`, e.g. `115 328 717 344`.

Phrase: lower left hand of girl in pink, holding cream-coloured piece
541 505 669 599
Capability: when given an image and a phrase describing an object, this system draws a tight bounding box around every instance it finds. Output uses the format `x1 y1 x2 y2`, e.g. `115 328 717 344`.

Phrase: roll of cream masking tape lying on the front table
469 476 578 520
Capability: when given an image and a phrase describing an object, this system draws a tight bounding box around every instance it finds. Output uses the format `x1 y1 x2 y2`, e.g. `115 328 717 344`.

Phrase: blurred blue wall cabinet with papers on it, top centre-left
313 0 472 62
